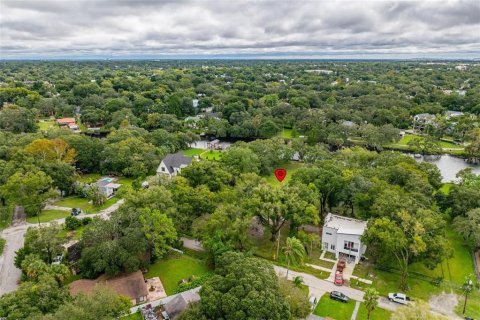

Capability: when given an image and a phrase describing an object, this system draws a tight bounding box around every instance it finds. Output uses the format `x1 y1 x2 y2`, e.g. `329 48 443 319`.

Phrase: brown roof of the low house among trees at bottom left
70 270 148 304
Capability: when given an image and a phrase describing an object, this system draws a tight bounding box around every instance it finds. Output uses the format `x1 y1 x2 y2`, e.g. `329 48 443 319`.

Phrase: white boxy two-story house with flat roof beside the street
322 213 367 263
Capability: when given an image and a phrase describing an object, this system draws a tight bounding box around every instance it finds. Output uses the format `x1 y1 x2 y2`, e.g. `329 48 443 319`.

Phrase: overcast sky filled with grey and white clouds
0 0 480 59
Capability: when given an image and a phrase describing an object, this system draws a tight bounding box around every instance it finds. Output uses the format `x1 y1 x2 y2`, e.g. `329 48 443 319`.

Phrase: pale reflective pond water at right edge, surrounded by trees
410 154 480 182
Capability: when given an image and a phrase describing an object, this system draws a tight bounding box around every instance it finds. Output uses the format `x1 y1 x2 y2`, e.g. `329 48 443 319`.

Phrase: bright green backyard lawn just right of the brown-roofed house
145 253 209 295
